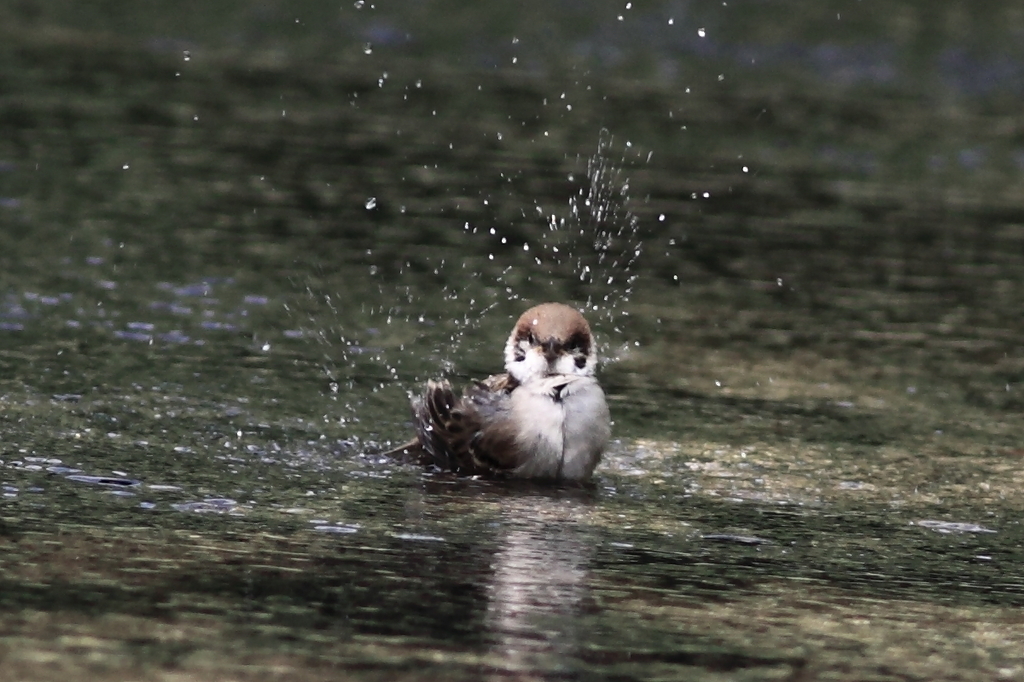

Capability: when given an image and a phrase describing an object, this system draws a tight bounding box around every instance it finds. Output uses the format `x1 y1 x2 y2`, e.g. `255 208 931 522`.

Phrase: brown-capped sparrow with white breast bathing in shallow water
387 303 611 482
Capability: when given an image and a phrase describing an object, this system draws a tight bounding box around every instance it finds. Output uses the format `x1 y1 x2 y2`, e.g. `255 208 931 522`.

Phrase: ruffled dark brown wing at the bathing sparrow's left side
413 374 517 475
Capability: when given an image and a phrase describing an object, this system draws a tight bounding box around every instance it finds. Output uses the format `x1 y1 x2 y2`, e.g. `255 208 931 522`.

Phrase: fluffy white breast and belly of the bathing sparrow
511 375 611 480
